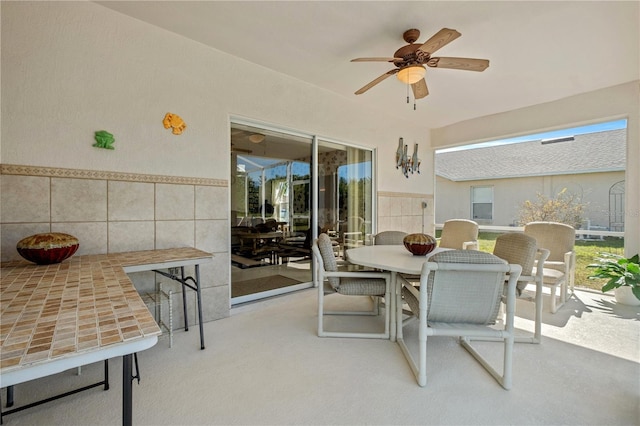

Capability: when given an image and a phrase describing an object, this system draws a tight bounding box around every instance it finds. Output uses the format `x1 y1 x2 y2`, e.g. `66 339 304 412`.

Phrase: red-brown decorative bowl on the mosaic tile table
16 232 80 265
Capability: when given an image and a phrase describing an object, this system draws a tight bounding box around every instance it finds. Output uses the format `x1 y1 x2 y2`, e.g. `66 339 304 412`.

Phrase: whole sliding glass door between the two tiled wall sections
230 120 373 305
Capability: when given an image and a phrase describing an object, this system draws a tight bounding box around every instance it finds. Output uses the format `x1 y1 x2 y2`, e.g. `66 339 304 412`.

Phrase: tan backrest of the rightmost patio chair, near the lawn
524 222 576 262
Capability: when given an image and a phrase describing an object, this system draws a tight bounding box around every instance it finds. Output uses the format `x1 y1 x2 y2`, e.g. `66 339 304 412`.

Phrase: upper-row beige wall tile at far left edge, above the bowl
0 175 51 223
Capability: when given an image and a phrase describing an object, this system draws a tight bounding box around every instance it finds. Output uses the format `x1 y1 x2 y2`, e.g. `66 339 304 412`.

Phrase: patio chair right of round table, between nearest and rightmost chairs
493 232 549 343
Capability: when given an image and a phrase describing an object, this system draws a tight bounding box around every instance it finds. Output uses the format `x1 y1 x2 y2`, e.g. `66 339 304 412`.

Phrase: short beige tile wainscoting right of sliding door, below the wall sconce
378 191 435 236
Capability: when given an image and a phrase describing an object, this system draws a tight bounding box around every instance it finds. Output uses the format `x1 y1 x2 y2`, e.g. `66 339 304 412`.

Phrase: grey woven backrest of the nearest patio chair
420 250 510 325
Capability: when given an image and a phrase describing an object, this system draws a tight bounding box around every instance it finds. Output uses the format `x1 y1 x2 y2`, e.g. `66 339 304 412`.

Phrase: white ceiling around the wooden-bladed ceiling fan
99 1 640 127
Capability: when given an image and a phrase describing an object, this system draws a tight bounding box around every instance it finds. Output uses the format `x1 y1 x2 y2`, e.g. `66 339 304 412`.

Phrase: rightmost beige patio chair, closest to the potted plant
524 222 576 314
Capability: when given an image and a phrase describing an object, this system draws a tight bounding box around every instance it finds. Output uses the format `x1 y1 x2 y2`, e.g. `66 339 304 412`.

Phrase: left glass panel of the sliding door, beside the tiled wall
230 123 312 304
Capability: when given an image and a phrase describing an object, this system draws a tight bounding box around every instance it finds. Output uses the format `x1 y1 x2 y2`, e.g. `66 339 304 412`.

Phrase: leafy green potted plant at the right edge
587 253 640 306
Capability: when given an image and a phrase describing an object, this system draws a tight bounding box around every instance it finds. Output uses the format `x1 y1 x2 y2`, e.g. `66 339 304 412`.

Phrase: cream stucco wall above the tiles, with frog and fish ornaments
1 2 433 193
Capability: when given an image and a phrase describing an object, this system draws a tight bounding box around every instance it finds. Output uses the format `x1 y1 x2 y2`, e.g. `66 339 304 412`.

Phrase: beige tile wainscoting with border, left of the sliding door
0 164 230 327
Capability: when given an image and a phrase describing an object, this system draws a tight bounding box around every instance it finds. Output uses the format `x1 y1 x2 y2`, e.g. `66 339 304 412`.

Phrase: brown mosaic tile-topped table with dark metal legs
0 248 212 425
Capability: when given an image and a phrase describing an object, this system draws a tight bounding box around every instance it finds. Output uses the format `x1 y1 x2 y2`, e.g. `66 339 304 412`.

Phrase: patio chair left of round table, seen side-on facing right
312 234 391 339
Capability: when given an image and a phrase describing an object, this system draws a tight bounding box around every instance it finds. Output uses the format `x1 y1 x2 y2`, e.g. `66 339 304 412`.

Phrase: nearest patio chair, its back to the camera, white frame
396 250 522 389
